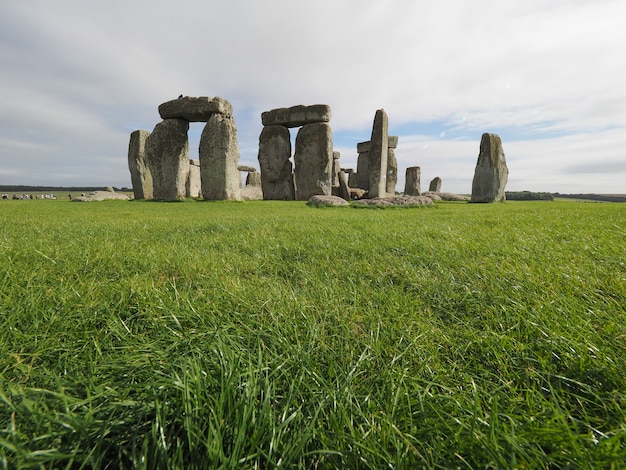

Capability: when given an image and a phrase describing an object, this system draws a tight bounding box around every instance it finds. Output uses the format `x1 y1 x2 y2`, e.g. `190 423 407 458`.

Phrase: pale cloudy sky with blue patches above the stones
0 0 626 194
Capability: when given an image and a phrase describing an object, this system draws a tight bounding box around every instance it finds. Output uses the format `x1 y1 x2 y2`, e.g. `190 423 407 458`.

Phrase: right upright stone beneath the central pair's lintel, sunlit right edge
294 122 333 201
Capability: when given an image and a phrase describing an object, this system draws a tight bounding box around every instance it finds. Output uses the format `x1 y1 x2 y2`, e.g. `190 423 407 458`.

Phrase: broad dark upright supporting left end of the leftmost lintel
145 119 189 201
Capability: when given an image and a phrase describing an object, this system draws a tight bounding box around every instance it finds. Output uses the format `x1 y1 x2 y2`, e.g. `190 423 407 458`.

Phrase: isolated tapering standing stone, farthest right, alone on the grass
470 133 509 202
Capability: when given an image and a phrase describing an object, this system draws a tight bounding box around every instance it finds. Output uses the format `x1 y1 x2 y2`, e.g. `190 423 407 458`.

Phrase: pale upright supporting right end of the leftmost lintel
199 114 241 201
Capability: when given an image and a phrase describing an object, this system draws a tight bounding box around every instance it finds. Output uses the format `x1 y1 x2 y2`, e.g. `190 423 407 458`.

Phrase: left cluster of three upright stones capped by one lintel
128 96 241 201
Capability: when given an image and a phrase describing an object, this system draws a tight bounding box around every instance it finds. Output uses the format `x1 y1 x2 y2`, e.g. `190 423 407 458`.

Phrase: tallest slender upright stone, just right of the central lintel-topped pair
367 109 389 199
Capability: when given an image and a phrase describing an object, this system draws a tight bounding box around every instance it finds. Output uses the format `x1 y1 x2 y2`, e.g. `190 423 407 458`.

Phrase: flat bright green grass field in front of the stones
0 199 626 468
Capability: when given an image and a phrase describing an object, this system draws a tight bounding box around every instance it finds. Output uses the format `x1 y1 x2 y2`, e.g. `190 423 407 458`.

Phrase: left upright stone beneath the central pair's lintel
258 126 296 201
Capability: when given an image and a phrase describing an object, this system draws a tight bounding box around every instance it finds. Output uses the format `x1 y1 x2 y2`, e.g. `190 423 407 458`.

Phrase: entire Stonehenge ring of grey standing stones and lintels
128 96 508 206
